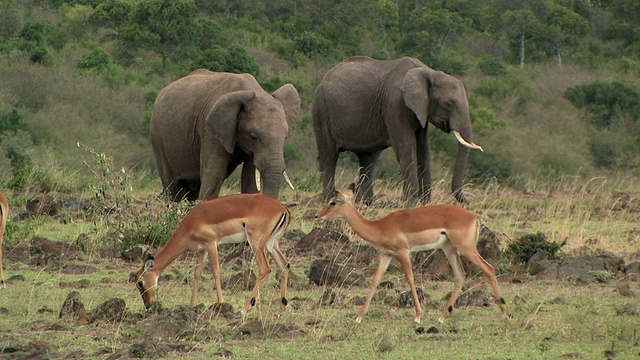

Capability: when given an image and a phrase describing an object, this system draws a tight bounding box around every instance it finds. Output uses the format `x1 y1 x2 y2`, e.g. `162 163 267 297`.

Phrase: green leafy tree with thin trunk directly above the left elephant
119 0 198 72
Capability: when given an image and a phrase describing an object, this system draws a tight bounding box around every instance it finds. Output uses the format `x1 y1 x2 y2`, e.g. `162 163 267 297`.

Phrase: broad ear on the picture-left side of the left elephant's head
206 90 256 154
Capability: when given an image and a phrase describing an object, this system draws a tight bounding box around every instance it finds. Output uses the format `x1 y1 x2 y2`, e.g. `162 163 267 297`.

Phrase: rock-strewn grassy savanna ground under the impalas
0 172 640 359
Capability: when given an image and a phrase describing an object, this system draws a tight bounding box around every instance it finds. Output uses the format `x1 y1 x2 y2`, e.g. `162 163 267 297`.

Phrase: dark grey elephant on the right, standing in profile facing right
311 56 482 203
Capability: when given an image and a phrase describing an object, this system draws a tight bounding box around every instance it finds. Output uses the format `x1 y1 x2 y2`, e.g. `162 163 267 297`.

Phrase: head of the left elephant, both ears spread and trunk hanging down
206 84 300 197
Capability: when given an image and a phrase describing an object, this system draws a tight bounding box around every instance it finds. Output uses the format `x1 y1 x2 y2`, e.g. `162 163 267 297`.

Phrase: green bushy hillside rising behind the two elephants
0 0 640 197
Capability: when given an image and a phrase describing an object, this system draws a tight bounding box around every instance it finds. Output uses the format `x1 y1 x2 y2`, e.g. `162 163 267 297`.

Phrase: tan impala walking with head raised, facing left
319 192 504 323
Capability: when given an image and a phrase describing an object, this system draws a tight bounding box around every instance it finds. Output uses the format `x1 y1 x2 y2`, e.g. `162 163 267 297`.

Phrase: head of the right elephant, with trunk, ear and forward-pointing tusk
402 66 482 202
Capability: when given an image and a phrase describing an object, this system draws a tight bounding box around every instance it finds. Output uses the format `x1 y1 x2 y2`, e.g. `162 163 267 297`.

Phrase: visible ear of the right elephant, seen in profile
401 67 435 128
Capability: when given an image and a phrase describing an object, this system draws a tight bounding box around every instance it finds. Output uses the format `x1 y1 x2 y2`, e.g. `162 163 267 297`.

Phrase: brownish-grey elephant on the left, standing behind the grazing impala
150 69 300 201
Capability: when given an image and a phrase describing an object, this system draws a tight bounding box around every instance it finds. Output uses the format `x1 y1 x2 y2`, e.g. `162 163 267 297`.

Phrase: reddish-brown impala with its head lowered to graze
134 194 291 314
